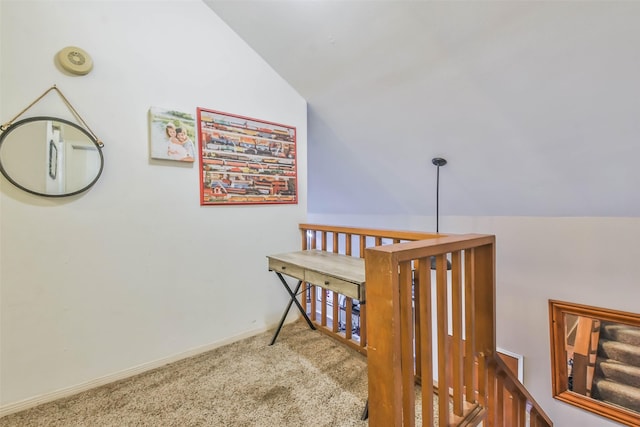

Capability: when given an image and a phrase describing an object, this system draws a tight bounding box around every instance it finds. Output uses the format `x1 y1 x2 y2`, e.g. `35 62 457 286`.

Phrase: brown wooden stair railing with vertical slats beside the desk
300 224 553 427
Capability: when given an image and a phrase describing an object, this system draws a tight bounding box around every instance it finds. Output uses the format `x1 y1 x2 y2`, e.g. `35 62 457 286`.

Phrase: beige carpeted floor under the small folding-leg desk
0 322 384 427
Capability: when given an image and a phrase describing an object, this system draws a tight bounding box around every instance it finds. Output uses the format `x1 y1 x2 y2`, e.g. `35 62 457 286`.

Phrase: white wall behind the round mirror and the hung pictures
0 0 307 409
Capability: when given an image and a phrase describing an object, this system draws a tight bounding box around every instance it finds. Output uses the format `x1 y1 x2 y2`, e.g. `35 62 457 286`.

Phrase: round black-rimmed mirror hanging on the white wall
0 117 104 197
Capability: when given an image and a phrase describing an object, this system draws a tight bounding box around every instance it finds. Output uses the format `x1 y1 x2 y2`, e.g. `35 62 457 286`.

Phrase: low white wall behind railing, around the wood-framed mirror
308 212 640 427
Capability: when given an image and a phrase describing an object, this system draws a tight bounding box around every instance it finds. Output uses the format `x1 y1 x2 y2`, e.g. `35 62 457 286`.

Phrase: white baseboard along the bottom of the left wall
0 325 275 418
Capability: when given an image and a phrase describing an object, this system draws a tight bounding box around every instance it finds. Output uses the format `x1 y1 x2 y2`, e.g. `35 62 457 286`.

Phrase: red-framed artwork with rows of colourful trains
197 108 298 206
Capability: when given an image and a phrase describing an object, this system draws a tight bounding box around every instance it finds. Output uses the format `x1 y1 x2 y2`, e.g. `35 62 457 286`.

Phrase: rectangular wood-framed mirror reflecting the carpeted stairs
549 300 640 426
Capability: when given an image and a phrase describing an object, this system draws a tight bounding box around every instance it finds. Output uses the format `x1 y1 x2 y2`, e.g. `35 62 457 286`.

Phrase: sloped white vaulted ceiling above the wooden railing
205 0 640 217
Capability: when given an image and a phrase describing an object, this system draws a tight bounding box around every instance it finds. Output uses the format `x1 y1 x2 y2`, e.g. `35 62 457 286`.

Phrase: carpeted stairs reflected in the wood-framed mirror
591 322 640 412
